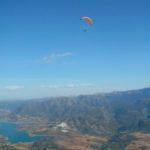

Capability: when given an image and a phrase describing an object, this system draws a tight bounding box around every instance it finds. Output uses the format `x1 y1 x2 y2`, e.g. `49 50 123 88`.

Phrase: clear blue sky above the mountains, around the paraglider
0 0 150 99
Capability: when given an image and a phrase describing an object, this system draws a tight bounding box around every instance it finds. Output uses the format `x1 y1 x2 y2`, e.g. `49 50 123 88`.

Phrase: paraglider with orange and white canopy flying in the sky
80 17 94 32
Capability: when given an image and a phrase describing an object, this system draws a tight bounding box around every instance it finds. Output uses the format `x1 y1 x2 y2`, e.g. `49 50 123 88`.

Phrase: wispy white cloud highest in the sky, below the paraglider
42 52 73 64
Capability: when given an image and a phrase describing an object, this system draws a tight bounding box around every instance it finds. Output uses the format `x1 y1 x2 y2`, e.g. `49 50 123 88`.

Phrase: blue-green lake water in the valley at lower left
0 123 44 143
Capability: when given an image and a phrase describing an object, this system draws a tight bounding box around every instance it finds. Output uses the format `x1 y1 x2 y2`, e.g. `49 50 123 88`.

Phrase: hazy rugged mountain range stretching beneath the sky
0 88 150 136
